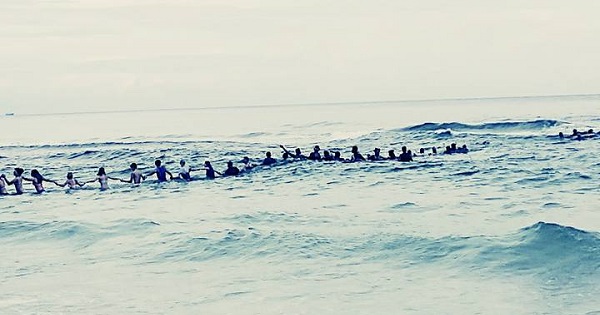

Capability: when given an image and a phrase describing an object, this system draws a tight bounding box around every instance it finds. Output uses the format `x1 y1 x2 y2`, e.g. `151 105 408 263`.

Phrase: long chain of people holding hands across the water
0 143 469 195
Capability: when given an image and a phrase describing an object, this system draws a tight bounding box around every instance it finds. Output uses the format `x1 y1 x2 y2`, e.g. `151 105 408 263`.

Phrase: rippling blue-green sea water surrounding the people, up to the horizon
0 95 600 314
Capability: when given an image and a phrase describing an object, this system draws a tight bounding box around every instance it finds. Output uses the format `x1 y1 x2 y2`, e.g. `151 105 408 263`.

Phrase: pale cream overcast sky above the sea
0 0 600 113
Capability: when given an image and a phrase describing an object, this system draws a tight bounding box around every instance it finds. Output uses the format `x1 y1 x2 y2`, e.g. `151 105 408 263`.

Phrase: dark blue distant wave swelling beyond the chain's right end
401 119 564 131
